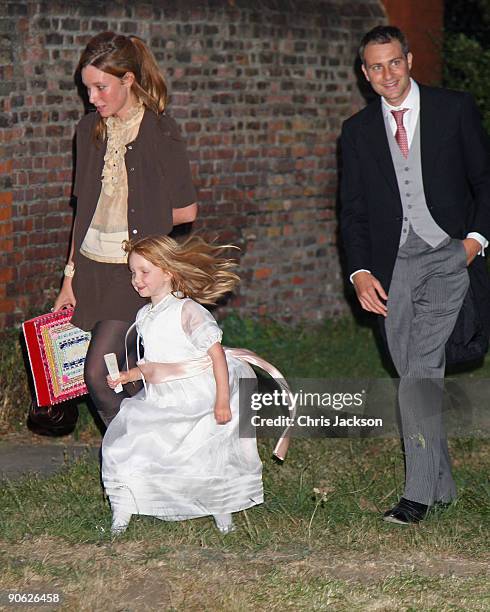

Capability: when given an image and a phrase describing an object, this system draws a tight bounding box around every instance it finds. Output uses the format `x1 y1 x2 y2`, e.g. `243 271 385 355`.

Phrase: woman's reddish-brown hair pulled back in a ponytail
77 32 167 139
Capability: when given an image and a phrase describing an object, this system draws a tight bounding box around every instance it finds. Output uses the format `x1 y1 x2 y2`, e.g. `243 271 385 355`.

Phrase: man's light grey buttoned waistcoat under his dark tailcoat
385 117 448 247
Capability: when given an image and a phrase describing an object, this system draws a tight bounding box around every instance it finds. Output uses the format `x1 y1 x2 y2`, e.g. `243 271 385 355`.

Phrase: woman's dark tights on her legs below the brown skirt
84 321 140 426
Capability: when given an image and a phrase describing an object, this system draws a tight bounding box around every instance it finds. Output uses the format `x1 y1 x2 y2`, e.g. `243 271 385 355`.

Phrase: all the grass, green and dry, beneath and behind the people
0 317 490 612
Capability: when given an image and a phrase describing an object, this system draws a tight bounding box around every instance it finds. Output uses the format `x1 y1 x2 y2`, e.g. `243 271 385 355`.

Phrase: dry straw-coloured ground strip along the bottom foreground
0 537 488 612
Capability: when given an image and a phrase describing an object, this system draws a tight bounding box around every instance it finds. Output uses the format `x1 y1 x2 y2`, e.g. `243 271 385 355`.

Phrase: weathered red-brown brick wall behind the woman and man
0 0 385 326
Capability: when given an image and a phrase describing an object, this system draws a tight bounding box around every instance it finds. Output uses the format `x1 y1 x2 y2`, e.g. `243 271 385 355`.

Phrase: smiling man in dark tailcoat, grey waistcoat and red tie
341 26 490 525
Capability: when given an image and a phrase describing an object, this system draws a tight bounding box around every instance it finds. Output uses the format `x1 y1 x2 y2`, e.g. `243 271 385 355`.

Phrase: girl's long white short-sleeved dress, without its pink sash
102 295 263 521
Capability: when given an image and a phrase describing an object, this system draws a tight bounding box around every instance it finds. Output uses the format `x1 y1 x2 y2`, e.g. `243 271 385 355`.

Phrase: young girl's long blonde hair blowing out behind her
123 236 240 304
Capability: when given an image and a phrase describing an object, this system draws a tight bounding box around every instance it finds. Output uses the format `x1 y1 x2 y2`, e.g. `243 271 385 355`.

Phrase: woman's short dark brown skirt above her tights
71 254 148 331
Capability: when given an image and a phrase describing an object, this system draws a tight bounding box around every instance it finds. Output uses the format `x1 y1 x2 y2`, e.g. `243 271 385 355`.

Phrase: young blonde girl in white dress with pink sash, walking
102 236 290 534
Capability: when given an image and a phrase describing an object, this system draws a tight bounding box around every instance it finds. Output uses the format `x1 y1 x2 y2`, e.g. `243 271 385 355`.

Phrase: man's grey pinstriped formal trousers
385 229 469 506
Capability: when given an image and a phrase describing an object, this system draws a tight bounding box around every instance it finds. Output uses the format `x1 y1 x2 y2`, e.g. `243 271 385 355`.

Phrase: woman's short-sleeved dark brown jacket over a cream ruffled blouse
73 110 196 262
